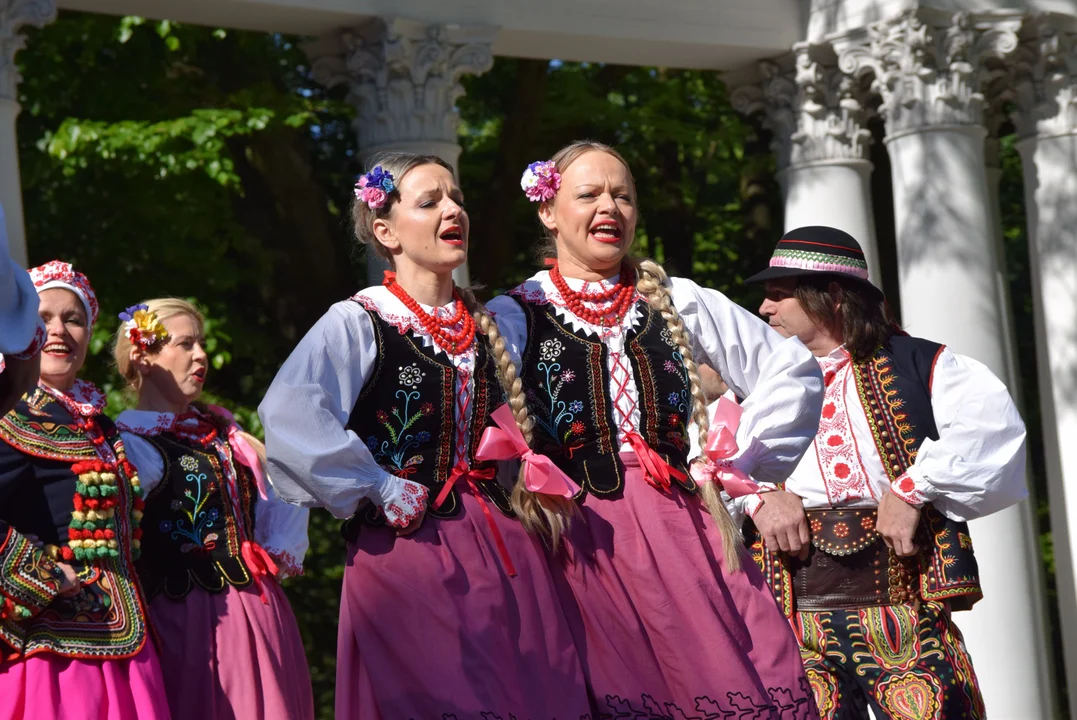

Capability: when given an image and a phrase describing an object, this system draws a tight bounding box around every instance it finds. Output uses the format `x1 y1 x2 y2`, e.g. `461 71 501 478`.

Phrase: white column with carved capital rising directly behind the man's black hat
731 43 882 287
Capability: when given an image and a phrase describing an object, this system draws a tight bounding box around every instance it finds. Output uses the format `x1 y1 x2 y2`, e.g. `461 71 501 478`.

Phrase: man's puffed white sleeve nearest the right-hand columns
892 349 1029 521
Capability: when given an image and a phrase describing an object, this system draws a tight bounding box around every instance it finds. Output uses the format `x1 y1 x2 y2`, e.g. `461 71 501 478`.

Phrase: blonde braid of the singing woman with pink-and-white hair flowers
631 259 744 570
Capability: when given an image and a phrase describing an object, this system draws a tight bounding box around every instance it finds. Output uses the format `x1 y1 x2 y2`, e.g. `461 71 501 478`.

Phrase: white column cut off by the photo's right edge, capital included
1013 16 1077 714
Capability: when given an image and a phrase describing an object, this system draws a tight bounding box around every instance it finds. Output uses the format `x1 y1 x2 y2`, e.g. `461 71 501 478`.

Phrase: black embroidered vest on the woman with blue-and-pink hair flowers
345 309 513 537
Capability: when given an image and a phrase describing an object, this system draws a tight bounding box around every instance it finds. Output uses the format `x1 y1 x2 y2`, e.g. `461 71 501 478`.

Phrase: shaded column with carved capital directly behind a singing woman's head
308 18 495 286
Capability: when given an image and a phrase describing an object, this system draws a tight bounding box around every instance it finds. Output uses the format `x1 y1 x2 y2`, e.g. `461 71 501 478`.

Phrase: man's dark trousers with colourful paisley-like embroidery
791 602 984 720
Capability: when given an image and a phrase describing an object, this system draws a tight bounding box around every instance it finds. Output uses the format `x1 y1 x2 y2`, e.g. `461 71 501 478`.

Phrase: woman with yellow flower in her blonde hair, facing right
113 298 314 720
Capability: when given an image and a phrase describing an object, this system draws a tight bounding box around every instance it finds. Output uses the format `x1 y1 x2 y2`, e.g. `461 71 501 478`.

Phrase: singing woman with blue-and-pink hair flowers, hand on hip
258 153 591 720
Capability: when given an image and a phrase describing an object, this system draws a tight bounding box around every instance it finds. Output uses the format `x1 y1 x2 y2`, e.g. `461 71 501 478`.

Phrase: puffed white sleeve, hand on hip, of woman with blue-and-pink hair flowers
258 300 406 518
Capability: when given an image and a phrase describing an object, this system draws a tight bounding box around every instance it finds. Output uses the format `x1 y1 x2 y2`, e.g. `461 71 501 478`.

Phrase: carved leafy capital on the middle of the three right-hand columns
838 11 1020 136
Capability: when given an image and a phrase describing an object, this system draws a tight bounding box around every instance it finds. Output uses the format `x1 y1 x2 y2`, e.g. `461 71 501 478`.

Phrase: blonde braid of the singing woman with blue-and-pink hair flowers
460 290 578 552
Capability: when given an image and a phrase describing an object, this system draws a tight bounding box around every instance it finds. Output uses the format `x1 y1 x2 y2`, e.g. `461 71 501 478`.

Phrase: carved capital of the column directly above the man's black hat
731 43 871 169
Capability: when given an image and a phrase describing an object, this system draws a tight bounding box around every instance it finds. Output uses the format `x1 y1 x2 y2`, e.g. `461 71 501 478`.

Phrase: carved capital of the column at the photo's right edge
1011 14 1077 138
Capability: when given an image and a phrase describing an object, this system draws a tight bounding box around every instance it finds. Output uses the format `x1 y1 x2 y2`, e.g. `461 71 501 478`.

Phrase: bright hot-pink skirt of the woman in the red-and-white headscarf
0 639 170 720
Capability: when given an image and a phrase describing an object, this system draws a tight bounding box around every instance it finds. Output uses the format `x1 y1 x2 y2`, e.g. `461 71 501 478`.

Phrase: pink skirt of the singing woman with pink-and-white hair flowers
550 453 819 720
